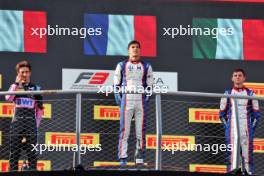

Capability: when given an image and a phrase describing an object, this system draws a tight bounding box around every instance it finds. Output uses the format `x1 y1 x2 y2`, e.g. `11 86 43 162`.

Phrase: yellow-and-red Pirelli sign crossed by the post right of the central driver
146 134 195 151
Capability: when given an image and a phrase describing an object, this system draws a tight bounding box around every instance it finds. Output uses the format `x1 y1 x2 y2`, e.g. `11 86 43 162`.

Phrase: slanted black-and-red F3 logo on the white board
74 72 109 85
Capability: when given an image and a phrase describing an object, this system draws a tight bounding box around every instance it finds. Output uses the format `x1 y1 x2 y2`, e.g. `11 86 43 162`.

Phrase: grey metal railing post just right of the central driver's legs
155 94 162 170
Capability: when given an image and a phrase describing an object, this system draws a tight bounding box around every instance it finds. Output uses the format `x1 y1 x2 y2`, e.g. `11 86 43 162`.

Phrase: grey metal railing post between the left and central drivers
74 93 82 167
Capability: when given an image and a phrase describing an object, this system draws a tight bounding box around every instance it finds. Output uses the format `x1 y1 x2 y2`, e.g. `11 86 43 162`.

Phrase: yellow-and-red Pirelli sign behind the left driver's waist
0 103 52 118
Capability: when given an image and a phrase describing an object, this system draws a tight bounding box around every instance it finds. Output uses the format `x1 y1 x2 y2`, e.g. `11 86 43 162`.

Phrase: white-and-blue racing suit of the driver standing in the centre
114 61 154 159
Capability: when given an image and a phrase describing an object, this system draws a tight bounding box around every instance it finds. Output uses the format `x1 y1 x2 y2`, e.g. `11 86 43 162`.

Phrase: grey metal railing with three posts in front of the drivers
0 90 264 173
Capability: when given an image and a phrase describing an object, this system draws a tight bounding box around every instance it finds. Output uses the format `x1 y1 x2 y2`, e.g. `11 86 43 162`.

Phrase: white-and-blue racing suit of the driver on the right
220 87 260 174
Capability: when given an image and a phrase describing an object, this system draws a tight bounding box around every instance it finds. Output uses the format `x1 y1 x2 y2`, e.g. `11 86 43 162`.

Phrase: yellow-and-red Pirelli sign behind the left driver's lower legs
0 160 51 172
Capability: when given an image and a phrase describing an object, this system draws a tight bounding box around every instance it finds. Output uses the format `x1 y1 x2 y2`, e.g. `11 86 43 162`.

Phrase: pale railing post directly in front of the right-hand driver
231 98 240 169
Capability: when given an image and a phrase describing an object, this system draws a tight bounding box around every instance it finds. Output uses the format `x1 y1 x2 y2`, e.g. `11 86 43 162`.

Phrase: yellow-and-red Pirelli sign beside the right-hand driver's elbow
189 108 221 123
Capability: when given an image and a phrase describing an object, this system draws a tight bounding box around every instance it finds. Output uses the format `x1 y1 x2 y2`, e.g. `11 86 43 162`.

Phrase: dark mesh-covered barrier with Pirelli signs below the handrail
0 91 264 174
